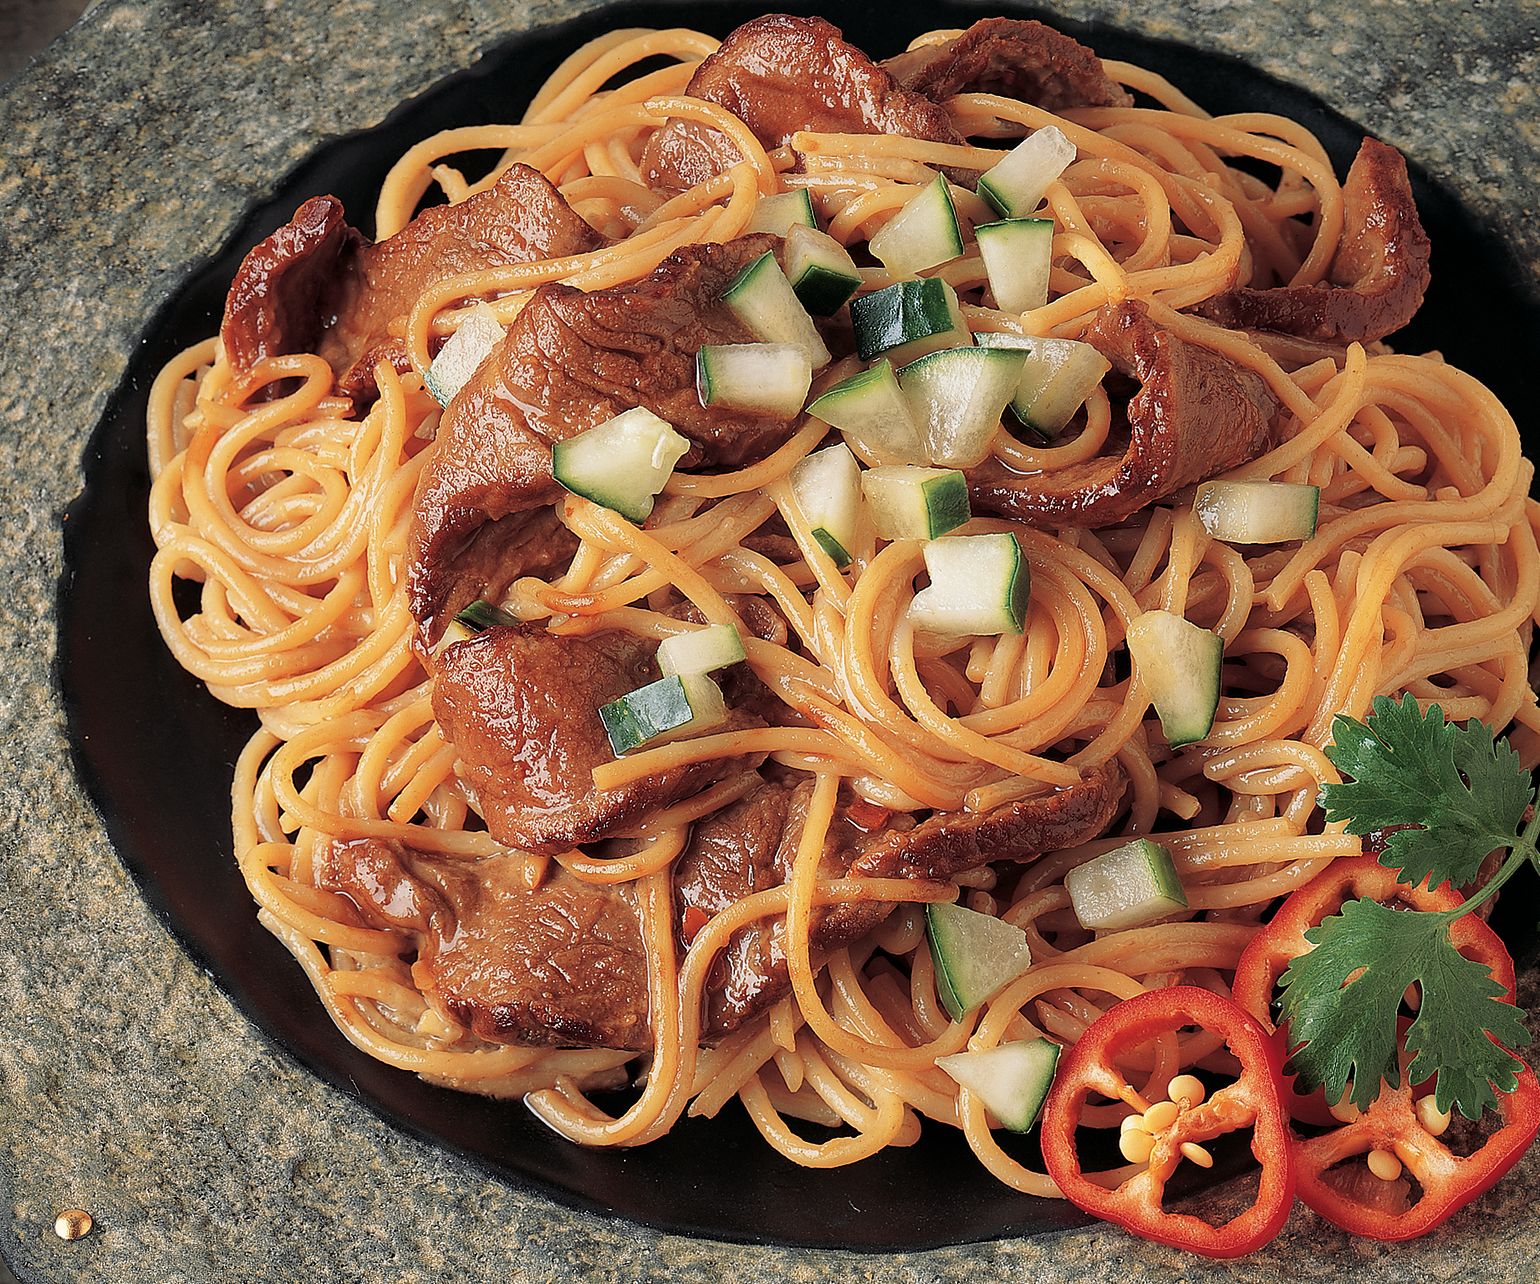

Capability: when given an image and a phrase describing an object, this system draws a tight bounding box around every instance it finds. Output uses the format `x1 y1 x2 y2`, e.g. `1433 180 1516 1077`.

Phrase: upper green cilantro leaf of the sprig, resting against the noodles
1321 696 1534 887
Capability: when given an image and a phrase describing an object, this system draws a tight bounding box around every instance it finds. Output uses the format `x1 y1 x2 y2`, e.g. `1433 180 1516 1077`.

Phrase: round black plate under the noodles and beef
59 0 1540 1250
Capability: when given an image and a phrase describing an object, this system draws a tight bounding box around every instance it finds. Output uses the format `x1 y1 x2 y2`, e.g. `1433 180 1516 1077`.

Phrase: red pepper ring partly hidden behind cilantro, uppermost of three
1230 856 1514 1127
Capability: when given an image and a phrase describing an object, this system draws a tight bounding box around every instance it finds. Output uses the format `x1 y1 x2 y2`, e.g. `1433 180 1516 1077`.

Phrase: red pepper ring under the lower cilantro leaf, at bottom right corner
1295 1053 1540 1239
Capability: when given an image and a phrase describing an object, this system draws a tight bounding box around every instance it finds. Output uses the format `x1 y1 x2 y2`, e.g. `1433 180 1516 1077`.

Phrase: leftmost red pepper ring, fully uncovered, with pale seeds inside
1043 985 1294 1258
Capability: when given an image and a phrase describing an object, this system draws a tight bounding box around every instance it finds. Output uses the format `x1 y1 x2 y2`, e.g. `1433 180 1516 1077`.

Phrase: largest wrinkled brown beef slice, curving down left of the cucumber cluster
408 236 795 637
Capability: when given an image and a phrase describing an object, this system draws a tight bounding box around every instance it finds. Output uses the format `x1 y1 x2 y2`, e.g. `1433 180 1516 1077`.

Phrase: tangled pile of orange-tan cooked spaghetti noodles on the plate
149 15 1540 1196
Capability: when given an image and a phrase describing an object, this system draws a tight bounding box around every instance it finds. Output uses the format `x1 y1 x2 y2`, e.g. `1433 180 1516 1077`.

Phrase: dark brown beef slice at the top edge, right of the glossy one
881 18 1133 112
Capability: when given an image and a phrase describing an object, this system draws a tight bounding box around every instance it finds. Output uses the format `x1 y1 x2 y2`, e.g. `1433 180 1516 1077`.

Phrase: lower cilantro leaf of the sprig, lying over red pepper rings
1280 899 1529 1119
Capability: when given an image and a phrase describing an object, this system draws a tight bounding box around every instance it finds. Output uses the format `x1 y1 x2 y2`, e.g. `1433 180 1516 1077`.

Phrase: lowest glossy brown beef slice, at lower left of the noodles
316 839 651 1052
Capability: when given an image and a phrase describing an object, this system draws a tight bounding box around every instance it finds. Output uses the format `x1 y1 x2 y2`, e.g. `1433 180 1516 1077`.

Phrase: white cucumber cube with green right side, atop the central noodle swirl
909 533 1032 637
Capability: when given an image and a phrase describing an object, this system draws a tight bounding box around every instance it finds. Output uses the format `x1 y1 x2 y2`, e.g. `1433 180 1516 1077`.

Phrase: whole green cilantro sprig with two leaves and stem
1280 696 1540 1119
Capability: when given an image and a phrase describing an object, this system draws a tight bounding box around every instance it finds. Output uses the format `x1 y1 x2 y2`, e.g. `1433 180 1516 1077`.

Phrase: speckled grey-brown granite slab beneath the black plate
0 0 1540 1284
